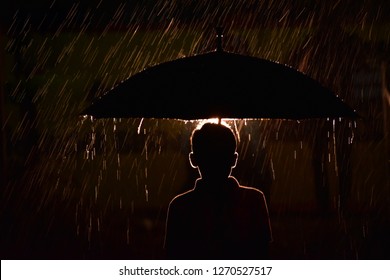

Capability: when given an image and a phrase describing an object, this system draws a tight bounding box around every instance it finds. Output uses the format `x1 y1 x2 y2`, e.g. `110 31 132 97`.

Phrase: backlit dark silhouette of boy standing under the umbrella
165 123 272 259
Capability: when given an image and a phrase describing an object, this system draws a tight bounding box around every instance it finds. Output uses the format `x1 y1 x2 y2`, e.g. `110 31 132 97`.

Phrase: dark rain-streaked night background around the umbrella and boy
0 0 390 259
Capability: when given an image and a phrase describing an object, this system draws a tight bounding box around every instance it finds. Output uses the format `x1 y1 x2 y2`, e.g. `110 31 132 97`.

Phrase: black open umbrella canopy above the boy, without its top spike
81 49 358 120
